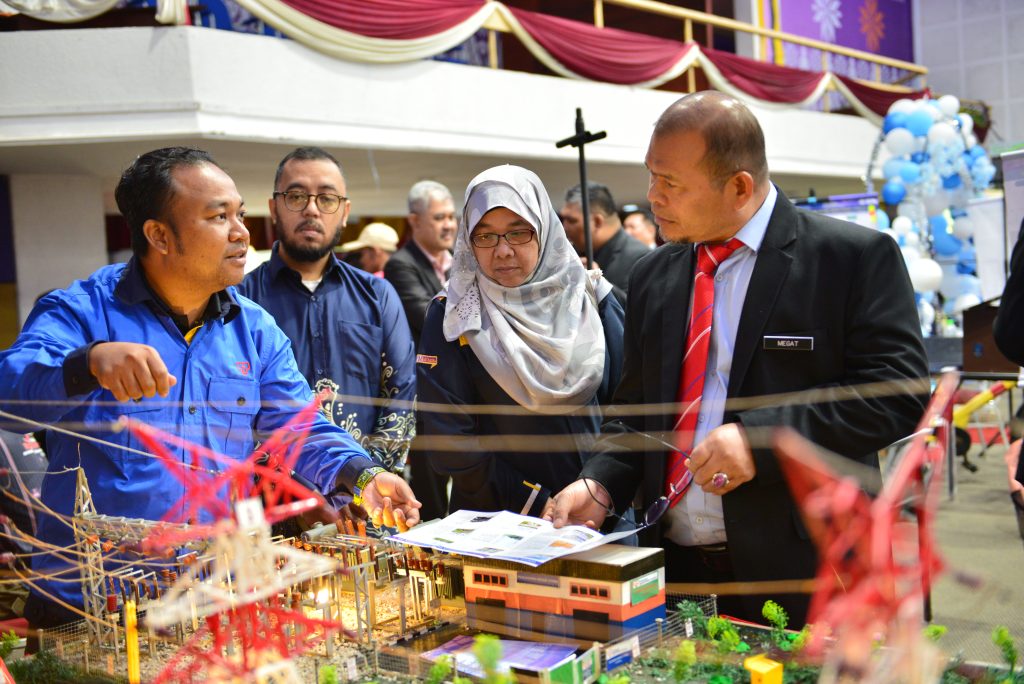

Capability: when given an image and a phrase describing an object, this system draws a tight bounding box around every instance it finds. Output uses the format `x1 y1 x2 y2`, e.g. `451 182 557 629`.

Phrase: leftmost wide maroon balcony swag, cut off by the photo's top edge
282 0 485 40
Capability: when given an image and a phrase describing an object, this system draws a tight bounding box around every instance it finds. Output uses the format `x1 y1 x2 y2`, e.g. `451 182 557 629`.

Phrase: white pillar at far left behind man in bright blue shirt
9 174 108 325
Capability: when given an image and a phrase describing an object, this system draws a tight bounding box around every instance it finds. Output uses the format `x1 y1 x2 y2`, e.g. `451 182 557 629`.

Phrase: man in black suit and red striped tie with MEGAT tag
546 92 928 627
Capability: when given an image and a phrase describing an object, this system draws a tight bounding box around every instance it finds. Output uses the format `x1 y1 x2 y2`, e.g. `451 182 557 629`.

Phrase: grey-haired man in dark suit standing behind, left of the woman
384 180 459 520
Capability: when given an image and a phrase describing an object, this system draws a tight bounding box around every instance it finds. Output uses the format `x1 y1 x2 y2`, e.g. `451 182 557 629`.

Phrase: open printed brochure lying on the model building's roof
391 511 636 567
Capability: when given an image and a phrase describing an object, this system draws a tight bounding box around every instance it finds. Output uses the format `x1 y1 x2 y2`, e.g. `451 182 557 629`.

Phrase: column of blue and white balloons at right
867 95 995 335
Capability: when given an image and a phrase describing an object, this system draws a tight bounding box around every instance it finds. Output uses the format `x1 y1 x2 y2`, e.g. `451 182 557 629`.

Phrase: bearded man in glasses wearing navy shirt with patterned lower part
239 147 416 473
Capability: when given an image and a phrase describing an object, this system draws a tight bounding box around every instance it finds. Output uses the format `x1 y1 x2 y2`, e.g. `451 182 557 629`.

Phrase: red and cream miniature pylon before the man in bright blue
117 399 352 682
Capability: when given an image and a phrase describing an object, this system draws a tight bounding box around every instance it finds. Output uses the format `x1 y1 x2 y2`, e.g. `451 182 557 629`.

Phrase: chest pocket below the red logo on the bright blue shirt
207 378 260 459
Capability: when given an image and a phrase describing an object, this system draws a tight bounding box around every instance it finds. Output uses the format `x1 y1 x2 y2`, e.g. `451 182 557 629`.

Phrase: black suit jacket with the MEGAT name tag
583 193 928 593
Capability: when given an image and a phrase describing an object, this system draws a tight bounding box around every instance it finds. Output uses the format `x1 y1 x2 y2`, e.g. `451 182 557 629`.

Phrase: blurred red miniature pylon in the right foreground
775 373 958 682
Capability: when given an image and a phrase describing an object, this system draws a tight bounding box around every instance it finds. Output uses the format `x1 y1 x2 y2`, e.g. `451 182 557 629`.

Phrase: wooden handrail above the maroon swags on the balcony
594 0 928 81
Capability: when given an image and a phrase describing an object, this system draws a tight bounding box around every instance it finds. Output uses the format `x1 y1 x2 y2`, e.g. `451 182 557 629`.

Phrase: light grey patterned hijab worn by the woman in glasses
443 166 611 414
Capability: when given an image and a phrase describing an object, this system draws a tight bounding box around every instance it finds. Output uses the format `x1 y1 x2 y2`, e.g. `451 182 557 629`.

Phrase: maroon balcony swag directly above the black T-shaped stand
509 7 689 85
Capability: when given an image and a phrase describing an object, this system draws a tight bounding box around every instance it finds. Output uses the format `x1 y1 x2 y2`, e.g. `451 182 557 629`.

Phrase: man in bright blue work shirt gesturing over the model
0 147 420 627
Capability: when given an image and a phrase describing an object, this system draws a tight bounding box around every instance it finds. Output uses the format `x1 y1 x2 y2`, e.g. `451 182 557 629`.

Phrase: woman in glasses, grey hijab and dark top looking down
417 166 624 515
